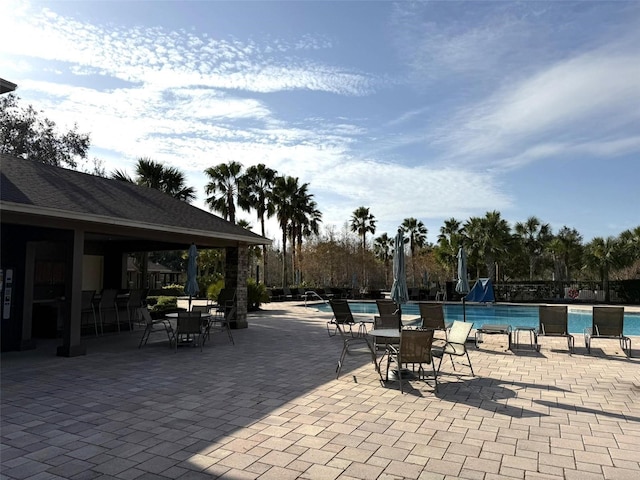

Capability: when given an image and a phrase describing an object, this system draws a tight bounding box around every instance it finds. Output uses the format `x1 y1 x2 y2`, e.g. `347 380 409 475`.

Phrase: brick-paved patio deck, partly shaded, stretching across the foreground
0 302 640 480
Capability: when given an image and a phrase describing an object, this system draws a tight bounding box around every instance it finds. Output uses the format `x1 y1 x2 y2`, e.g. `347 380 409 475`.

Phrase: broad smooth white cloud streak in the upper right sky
432 50 640 166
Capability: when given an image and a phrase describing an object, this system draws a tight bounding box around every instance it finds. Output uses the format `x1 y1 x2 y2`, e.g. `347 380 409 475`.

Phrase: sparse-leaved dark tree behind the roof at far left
0 94 90 169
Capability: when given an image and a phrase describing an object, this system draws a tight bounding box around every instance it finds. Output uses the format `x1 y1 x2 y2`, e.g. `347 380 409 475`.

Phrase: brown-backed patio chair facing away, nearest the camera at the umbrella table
385 329 438 393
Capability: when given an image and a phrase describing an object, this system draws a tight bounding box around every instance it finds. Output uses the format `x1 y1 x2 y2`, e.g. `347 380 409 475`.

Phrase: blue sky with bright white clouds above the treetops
0 0 640 242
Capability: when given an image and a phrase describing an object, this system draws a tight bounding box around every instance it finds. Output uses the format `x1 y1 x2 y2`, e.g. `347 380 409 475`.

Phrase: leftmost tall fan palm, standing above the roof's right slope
204 162 242 223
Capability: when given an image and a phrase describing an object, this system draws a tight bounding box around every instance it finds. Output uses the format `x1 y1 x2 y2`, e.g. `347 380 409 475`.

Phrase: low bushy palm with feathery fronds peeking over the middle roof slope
111 157 196 203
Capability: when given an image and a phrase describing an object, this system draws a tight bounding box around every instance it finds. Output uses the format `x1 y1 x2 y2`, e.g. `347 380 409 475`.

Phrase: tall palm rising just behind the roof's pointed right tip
238 163 277 285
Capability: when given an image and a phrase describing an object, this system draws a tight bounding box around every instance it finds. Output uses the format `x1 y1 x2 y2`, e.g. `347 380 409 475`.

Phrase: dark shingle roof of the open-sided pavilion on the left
0 154 269 248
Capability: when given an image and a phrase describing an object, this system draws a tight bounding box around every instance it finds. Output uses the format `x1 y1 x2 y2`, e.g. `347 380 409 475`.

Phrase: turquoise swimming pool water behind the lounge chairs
313 302 640 335
